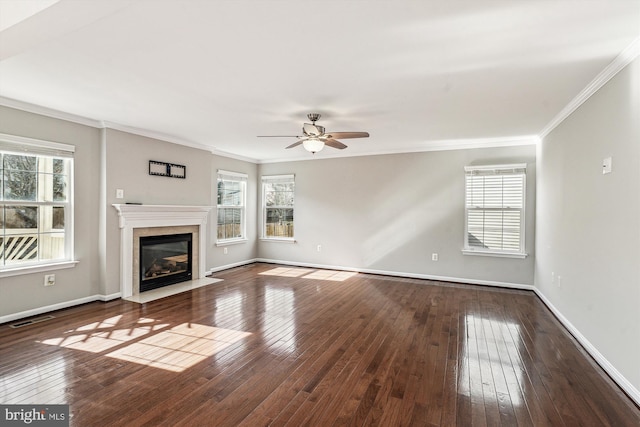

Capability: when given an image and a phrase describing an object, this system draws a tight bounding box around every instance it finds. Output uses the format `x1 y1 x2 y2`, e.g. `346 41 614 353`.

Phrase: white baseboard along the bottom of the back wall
254 258 534 291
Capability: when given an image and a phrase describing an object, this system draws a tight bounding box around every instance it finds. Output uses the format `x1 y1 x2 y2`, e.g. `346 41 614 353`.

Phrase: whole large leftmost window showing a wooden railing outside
0 135 74 271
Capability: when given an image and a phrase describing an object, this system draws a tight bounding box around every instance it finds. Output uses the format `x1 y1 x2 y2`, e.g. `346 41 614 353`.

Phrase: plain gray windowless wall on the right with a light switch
535 59 640 399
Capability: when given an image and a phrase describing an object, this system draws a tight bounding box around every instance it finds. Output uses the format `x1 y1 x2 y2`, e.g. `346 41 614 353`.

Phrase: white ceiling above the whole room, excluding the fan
0 0 640 161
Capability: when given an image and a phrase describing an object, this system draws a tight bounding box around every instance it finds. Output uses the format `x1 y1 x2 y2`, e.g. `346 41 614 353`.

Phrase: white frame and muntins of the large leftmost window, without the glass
0 133 78 277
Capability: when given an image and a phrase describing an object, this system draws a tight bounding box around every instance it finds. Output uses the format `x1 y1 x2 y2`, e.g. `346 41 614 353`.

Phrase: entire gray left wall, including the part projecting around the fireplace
0 107 259 319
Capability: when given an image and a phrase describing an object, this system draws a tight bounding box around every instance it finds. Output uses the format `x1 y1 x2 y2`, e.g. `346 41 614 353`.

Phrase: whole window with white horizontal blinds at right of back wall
464 164 526 257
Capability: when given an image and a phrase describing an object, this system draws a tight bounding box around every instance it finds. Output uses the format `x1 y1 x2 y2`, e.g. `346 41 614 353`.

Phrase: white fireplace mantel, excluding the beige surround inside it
112 204 212 298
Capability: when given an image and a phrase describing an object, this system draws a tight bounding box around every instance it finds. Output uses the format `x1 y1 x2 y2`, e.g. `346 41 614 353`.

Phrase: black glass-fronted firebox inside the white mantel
139 233 193 292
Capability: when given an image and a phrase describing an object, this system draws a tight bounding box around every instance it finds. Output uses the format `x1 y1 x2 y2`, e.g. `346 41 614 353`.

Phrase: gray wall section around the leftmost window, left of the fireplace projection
0 106 100 318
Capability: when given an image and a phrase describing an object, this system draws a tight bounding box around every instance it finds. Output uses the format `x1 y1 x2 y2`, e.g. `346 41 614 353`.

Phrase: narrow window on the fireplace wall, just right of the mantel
217 170 247 243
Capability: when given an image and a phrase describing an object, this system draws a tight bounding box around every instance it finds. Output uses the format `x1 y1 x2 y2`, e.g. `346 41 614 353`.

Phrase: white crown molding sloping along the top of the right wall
540 37 640 139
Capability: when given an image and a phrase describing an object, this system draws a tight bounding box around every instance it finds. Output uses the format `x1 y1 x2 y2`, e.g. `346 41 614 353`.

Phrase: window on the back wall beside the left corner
262 175 295 241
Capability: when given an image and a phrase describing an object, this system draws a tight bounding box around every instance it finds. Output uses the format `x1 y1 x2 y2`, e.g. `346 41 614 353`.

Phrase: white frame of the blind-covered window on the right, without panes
462 163 528 258
